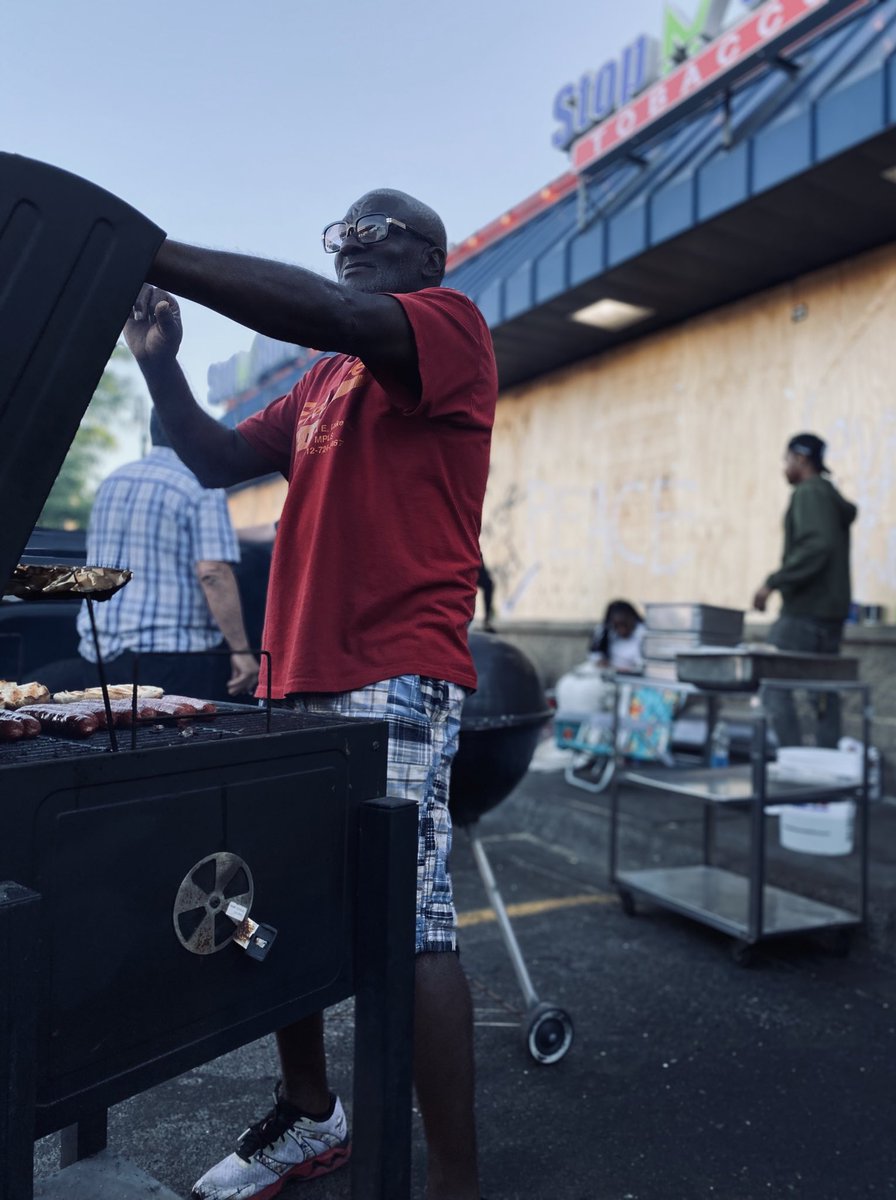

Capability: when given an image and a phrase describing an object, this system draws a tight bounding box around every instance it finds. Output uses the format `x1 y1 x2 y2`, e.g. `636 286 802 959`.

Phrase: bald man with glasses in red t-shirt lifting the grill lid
126 191 497 1200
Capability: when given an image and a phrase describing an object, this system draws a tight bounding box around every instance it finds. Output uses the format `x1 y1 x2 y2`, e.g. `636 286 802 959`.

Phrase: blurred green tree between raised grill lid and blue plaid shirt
37 343 144 529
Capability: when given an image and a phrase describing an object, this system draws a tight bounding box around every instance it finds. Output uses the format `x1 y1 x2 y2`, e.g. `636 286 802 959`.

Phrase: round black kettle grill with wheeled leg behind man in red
450 632 573 1063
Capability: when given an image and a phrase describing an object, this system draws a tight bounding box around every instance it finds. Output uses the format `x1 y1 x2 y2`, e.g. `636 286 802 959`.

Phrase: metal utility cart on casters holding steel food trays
609 679 871 965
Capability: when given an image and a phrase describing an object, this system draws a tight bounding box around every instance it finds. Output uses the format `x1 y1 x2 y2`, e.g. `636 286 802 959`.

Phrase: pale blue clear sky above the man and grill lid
0 0 671 417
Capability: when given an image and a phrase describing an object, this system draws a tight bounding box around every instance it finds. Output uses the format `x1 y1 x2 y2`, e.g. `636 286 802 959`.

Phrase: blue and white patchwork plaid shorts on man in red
285 676 467 954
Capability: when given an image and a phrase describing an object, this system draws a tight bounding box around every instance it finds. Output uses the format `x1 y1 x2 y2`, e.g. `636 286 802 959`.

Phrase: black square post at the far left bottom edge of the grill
0 881 41 1200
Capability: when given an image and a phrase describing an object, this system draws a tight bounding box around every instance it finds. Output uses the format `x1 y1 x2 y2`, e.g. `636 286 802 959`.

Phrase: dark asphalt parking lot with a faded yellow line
35 739 896 1200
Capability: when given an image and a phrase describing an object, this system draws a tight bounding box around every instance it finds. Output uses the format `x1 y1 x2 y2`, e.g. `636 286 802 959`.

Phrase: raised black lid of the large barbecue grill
0 154 164 589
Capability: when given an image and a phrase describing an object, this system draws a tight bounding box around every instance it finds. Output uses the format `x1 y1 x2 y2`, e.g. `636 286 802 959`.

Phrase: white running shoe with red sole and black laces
191 1084 351 1200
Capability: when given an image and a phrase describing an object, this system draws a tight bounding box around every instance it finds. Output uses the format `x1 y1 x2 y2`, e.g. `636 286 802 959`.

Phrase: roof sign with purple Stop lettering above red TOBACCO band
553 0 846 172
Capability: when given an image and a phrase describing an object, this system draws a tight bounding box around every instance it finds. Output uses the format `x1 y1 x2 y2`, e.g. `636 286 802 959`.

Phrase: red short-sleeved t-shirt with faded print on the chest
239 288 498 697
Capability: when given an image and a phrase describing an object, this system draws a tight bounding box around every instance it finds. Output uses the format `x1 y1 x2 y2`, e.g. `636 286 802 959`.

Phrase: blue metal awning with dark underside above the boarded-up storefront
445 0 896 386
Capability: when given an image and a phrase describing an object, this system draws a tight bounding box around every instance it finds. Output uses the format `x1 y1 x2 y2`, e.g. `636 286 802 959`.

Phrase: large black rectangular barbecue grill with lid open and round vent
0 154 416 1200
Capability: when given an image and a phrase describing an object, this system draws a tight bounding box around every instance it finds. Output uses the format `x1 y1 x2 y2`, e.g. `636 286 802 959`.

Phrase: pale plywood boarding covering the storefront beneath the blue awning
482 238 896 622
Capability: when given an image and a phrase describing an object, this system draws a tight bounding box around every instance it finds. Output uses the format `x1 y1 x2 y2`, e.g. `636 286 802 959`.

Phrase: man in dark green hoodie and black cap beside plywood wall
753 433 858 748
